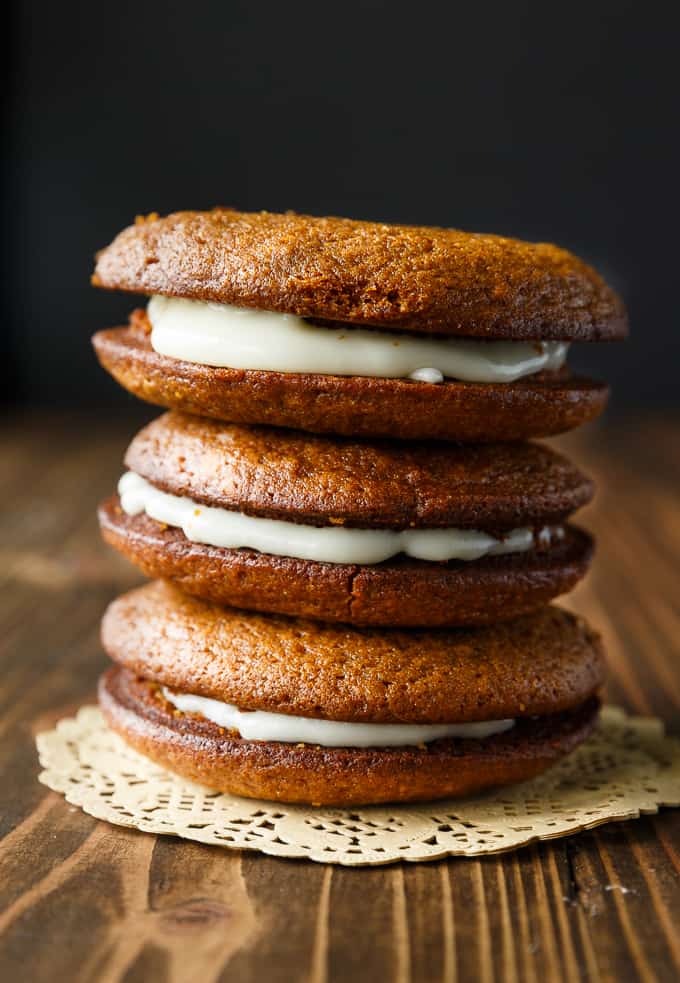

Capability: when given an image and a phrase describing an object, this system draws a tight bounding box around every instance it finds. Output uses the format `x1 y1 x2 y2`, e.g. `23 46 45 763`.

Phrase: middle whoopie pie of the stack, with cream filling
99 412 592 627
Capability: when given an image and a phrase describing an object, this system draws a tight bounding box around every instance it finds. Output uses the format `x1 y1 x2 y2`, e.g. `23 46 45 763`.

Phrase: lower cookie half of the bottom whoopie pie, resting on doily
99 668 598 806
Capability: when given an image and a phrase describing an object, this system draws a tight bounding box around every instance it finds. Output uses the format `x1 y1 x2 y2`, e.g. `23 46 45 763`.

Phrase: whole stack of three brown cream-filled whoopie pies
93 209 626 805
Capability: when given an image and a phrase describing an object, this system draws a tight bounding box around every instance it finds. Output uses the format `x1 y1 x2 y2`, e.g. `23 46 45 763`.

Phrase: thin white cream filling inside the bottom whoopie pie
163 687 515 747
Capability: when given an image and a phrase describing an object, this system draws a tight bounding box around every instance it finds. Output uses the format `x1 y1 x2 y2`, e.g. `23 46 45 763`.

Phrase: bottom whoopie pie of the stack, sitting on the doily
100 581 604 806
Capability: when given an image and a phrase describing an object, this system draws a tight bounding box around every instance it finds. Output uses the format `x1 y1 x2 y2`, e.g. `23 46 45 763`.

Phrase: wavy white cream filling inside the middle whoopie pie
118 471 564 564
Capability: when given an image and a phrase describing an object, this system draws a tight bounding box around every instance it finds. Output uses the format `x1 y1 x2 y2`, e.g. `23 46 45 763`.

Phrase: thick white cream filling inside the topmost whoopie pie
147 296 569 384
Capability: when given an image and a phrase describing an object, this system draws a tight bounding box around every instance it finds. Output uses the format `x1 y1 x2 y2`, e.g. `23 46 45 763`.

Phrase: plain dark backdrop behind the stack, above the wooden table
6 0 680 412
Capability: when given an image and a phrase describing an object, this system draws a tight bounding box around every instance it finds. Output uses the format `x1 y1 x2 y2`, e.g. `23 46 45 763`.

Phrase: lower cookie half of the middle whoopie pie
99 497 592 627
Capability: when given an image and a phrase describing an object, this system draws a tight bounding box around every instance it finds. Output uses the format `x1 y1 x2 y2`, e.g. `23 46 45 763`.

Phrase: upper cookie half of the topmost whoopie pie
93 208 626 340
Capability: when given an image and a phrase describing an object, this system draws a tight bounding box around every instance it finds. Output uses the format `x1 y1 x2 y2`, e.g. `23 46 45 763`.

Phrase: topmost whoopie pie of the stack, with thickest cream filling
93 208 626 442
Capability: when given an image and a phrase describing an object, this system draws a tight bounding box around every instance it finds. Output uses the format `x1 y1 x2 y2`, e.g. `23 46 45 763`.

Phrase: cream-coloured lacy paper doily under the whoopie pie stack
37 707 680 866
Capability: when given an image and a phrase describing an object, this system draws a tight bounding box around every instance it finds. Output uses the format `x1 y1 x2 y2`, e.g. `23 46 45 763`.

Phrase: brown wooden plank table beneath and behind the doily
0 411 680 983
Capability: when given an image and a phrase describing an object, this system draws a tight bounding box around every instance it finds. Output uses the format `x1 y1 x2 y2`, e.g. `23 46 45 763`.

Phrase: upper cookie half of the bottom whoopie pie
102 581 605 723
